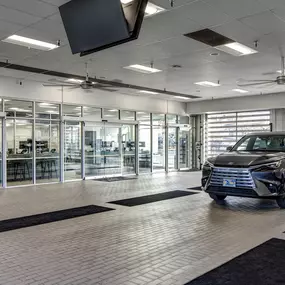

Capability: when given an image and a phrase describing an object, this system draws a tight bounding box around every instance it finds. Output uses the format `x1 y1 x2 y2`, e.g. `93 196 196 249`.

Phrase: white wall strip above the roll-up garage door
187 93 285 115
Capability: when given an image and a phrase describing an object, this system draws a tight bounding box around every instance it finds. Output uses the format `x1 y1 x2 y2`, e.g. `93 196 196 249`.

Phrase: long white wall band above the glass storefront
0 78 186 115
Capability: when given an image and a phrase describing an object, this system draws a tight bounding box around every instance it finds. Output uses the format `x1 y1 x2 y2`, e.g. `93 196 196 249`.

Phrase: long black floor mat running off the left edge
0 205 114 232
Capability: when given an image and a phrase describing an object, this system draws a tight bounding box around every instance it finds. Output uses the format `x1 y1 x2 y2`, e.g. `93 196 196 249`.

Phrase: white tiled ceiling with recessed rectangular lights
0 0 285 100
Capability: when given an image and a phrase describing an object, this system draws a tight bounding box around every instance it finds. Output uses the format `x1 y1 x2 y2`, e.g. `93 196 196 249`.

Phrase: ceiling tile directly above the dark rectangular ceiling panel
183 1 232 27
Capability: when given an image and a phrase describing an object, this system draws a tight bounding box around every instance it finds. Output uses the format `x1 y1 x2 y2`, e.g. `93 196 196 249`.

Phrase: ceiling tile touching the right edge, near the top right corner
240 11 285 35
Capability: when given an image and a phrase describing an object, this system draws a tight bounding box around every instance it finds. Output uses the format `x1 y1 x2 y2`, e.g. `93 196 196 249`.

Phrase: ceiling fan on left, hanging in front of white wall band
43 63 118 92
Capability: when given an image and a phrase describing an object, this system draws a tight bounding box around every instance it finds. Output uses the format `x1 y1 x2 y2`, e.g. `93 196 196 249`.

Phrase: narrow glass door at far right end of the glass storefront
178 128 192 169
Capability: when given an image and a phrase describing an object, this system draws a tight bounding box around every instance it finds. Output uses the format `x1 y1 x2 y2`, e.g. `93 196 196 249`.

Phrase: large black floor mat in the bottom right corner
186 238 285 285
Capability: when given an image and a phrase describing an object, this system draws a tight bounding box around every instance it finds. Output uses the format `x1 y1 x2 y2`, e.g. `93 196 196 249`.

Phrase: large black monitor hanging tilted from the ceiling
59 0 148 56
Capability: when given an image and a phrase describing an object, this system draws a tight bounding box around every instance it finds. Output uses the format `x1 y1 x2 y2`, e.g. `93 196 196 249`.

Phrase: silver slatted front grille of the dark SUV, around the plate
210 167 255 189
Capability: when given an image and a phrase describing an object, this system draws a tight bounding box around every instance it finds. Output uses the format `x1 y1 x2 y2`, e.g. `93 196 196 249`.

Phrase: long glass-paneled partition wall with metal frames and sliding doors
0 99 192 188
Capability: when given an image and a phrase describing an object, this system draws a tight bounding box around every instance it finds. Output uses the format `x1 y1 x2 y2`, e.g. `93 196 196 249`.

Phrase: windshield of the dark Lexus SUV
232 134 285 151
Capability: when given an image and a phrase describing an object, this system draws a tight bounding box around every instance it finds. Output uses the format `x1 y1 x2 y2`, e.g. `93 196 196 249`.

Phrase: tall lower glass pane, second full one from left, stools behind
35 120 60 183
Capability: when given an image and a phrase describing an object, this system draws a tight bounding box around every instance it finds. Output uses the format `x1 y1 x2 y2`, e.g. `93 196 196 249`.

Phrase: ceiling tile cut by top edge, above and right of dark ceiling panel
203 0 268 19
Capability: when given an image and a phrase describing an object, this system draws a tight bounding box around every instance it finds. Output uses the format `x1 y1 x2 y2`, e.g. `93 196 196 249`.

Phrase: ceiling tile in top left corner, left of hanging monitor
0 0 58 17
